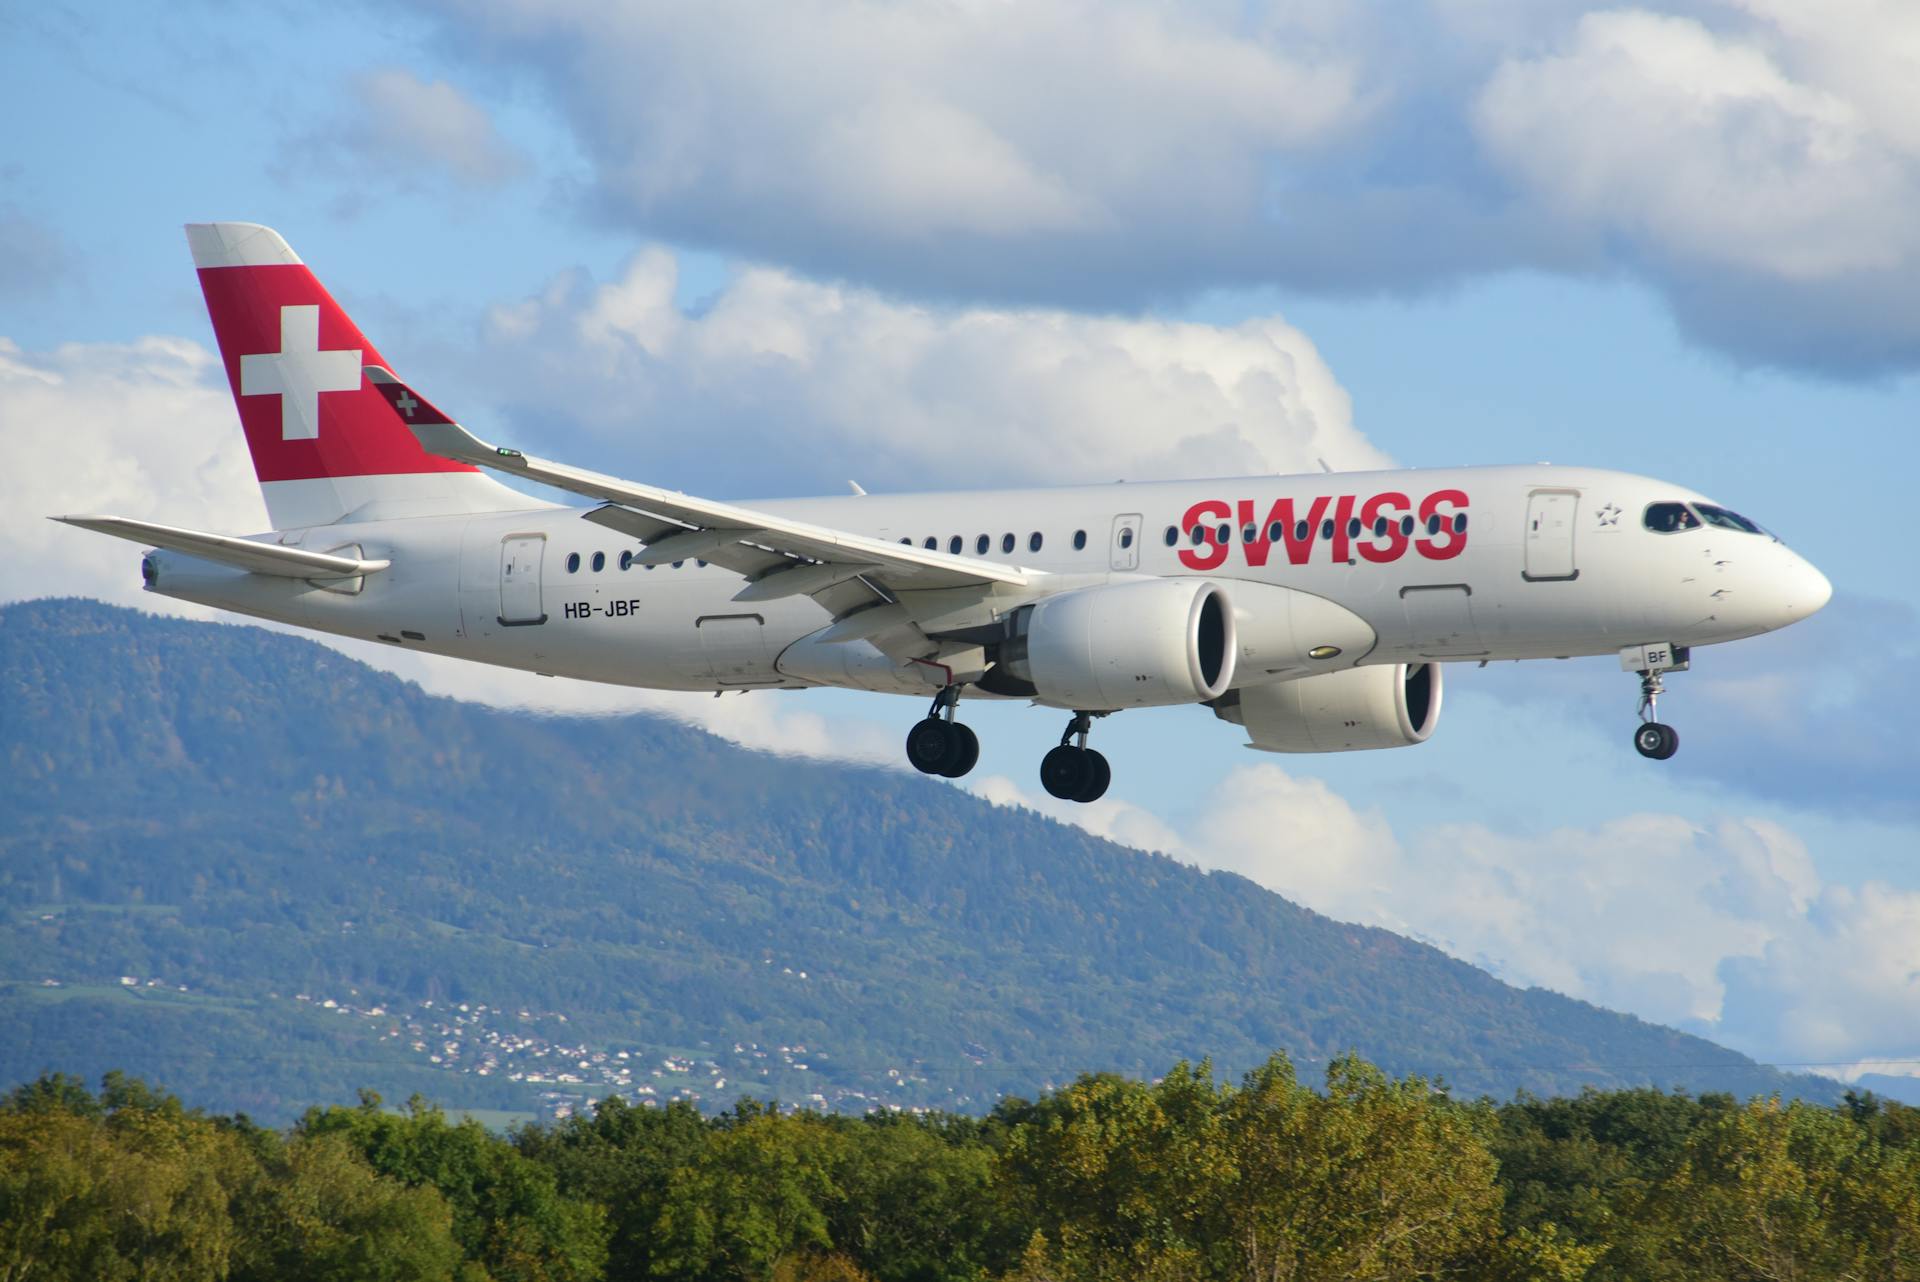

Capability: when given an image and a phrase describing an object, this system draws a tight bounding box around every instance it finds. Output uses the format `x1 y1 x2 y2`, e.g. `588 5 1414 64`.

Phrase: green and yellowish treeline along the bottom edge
0 1057 1920 1282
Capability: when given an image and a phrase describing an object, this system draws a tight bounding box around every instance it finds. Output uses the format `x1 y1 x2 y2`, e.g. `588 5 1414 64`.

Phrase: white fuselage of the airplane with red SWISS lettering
148 466 1828 693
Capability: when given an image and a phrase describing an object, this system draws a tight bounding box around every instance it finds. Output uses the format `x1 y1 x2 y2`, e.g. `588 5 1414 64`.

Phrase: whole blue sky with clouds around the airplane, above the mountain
0 0 1920 1090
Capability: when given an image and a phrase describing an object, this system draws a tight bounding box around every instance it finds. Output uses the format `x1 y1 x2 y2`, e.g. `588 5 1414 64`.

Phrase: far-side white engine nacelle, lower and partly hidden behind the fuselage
1213 664 1440 752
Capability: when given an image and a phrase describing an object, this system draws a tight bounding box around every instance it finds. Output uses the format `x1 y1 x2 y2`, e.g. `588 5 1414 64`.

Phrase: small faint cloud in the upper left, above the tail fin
276 67 528 192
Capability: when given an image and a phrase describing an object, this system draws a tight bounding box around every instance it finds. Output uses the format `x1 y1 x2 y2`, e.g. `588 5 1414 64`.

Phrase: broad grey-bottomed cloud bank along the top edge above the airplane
417 0 1920 372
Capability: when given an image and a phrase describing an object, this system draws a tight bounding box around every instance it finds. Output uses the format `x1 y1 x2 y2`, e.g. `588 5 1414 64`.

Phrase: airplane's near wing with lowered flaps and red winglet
367 365 1044 662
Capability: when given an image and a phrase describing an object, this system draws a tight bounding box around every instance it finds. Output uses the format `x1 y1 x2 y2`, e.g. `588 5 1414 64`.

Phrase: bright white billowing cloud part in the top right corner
1475 4 1920 282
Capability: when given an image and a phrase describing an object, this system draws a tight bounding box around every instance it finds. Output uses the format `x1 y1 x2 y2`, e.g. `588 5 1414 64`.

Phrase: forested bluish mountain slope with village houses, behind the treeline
0 601 1837 1119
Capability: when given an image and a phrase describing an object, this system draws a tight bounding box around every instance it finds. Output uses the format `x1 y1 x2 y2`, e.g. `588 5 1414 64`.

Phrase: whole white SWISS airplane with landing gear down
54 223 1832 802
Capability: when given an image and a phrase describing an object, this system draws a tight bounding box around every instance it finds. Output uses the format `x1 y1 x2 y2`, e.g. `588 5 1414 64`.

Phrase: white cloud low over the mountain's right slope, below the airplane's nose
975 764 1920 1075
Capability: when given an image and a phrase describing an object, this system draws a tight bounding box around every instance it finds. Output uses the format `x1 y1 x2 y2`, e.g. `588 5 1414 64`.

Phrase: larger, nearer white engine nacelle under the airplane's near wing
1000 580 1235 712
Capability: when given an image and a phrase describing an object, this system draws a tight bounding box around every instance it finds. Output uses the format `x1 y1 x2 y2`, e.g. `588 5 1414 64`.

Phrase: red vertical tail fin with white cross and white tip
186 223 474 484
